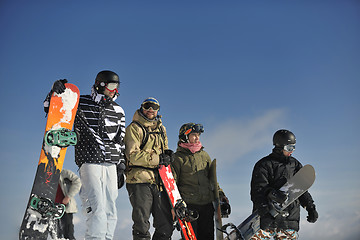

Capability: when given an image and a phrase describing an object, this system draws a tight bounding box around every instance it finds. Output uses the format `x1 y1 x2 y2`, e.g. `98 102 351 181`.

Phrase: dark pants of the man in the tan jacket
126 183 174 240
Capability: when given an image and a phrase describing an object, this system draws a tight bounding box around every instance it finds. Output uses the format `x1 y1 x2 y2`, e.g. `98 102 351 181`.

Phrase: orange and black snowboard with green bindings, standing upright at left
19 83 80 240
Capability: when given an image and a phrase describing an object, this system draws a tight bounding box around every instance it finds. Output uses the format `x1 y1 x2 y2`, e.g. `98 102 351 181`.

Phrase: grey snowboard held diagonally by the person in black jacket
223 165 315 240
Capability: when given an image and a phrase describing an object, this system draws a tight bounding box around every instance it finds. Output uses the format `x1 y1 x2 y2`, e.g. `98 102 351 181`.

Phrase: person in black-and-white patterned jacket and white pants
44 70 125 239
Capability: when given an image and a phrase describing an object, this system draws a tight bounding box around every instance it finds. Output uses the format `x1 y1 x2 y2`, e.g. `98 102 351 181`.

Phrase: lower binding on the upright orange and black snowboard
30 194 65 219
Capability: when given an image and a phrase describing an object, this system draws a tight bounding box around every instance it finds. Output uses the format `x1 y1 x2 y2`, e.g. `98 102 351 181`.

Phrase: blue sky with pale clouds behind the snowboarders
0 0 360 239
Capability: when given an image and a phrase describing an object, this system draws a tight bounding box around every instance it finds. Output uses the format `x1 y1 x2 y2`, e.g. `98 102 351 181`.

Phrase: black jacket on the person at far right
250 148 313 231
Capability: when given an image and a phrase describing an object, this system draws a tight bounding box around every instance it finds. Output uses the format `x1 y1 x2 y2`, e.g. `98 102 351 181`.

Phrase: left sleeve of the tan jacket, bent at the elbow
125 123 159 168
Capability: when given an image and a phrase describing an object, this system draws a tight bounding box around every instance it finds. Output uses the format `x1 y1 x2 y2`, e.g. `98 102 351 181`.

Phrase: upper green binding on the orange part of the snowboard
45 128 78 147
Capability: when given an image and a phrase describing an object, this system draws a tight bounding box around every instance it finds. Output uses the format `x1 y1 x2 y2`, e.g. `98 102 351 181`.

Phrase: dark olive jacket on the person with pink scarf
171 146 214 205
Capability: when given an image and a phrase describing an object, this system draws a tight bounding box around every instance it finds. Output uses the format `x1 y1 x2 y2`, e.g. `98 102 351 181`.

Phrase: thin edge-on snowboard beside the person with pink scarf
210 159 224 240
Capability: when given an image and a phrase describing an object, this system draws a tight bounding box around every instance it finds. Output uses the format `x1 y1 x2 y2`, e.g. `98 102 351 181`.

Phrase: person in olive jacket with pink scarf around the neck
171 123 228 240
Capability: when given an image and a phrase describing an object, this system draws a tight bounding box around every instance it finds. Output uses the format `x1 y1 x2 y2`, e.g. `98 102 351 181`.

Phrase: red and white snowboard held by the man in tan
159 165 196 240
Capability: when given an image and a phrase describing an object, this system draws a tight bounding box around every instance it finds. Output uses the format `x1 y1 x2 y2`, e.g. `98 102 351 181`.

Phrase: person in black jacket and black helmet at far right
250 129 318 240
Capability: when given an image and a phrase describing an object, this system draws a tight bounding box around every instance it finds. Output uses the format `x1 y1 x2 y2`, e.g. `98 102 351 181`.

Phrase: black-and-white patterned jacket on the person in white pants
44 87 125 167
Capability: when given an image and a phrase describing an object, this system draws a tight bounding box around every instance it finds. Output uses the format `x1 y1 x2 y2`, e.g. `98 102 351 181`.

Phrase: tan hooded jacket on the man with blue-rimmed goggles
125 110 168 184
